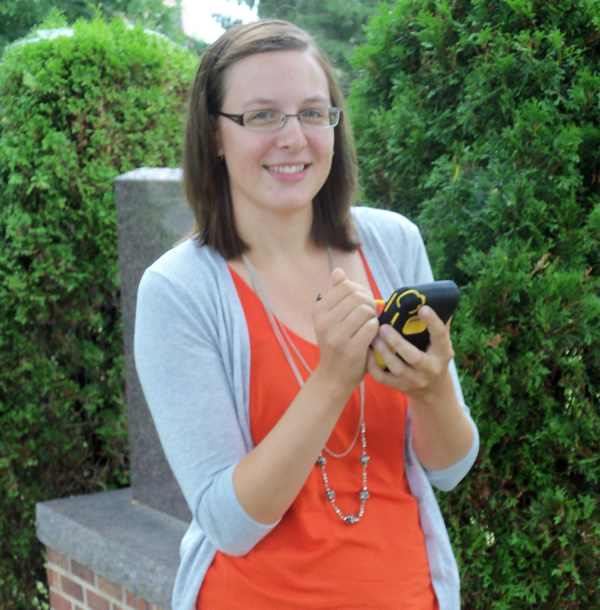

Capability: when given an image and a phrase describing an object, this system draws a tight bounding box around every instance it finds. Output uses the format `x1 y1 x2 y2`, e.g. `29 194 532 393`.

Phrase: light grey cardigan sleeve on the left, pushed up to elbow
134 268 276 555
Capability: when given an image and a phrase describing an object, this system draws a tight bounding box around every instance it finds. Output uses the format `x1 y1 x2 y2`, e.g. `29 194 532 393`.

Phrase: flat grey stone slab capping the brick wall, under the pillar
36 488 187 610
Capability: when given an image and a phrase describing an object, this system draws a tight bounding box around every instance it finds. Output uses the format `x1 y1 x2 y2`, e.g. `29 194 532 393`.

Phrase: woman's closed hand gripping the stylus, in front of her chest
313 268 379 388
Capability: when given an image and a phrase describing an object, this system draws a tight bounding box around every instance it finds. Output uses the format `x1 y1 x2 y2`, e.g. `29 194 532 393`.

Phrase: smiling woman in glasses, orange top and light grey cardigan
135 20 478 610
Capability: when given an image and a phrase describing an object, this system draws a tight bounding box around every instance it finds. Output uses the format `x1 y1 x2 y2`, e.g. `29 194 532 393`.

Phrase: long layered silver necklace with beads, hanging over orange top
242 248 370 525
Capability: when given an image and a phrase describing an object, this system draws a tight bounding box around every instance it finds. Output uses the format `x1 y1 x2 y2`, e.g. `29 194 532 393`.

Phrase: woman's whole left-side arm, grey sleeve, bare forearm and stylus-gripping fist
135 270 378 540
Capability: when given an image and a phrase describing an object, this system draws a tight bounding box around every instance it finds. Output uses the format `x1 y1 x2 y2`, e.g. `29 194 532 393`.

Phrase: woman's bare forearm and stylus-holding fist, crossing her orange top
234 269 378 523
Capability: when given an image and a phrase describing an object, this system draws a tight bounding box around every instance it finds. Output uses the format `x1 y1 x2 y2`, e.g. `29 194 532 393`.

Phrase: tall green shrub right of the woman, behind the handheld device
350 0 600 609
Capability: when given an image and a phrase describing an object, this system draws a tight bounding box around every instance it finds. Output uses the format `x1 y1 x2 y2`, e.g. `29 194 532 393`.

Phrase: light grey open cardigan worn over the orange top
134 207 479 610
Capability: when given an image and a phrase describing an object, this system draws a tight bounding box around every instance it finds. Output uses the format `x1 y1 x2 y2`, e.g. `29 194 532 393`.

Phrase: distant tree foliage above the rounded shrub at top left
0 0 185 49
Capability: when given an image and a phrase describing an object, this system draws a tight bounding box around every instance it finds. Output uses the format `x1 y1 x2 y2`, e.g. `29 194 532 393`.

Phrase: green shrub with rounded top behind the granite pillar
0 15 197 608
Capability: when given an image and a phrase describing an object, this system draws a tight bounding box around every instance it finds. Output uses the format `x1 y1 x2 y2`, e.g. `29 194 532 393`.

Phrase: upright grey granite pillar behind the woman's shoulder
115 168 193 521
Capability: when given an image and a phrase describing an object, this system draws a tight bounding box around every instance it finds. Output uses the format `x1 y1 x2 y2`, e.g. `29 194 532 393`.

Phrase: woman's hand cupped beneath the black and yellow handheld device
367 306 454 403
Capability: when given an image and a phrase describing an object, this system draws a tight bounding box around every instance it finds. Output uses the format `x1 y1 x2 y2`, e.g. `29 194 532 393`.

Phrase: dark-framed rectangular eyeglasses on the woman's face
217 106 342 131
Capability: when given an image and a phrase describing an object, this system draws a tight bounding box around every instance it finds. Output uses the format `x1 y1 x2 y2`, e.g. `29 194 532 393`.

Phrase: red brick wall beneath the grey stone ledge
46 547 161 610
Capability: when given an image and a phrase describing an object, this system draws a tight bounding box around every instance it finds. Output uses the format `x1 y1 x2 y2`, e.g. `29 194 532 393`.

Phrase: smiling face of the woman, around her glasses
217 51 334 230
